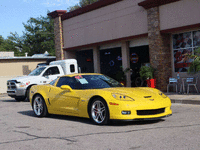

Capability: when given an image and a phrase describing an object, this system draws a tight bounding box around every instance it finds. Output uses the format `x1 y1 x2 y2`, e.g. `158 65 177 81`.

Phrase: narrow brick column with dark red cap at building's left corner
48 10 67 60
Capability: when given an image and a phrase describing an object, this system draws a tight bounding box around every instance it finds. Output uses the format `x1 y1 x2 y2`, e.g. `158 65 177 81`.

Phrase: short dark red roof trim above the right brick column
138 0 180 9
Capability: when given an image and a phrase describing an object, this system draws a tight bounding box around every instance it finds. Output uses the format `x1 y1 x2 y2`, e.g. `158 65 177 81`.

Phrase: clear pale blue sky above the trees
0 0 79 39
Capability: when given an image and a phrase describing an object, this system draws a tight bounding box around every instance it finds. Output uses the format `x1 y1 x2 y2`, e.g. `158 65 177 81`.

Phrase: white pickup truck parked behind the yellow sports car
7 59 78 101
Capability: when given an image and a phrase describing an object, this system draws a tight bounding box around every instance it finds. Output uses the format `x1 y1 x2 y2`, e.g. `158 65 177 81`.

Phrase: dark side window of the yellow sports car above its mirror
56 77 77 89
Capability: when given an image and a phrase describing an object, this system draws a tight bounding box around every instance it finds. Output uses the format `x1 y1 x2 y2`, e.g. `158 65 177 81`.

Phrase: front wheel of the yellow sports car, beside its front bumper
89 98 109 125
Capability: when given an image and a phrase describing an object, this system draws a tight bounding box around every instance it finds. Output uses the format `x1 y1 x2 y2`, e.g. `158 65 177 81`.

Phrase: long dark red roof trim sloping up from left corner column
61 0 122 21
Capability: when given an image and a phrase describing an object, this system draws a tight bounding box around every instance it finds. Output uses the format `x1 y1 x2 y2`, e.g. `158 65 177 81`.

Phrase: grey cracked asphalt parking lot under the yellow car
0 96 200 150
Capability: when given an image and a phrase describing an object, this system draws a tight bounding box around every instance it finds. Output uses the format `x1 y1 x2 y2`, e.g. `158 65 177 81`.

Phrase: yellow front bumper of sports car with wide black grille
108 98 172 120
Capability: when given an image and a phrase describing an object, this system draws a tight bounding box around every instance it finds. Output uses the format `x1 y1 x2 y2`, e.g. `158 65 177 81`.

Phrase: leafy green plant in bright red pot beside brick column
139 66 156 88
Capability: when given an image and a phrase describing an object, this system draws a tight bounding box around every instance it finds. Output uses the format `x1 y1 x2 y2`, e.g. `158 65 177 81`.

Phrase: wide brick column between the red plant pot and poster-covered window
147 7 172 91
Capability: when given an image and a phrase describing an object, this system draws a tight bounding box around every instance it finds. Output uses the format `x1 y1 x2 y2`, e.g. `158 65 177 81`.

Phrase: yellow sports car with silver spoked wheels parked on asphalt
30 73 172 125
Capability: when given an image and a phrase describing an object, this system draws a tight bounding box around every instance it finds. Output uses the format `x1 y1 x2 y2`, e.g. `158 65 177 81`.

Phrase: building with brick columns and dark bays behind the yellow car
48 0 200 91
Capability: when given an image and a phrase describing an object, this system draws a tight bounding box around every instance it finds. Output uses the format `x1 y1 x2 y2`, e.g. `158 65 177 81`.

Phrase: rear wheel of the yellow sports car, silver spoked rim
32 95 48 117
